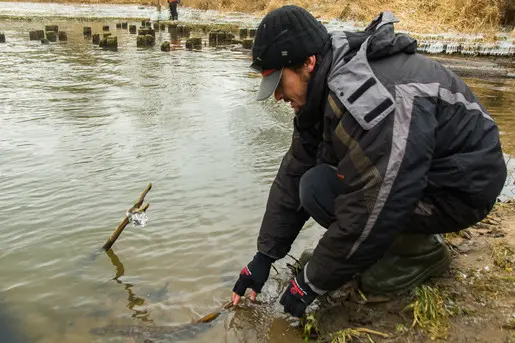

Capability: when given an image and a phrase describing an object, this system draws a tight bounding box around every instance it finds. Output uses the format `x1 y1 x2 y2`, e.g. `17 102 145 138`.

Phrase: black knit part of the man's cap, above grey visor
251 5 329 72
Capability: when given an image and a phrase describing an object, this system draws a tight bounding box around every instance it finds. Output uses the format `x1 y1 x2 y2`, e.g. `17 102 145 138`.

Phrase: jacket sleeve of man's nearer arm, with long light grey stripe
304 94 436 293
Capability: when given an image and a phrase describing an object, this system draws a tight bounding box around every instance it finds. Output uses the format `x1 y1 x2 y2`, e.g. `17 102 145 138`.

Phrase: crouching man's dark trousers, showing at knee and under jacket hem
299 164 496 234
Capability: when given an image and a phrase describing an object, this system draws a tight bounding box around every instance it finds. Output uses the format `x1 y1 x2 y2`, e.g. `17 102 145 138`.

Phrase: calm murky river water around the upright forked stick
0 3 515 343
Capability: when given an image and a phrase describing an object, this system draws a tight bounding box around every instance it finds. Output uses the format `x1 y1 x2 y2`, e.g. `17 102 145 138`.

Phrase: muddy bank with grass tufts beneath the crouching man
303 203 515 342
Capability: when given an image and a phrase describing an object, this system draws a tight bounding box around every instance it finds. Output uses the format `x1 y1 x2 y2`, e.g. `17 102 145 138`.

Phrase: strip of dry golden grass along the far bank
4 0 515 36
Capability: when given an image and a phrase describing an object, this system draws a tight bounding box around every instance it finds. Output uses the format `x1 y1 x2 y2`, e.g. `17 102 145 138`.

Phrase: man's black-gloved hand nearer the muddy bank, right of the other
280 270 318 318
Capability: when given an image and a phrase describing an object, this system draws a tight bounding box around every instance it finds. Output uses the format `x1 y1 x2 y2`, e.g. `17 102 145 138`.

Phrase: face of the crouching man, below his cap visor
274 56 316 113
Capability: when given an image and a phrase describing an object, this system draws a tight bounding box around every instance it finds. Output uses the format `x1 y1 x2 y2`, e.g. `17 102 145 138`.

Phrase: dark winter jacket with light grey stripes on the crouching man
258 12 506 293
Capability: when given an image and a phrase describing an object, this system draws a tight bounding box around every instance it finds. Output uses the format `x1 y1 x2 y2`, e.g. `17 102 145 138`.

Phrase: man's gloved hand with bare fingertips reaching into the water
232 251 274 305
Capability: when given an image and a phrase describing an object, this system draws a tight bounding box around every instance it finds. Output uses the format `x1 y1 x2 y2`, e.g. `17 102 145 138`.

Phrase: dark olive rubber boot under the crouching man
360 234 451 295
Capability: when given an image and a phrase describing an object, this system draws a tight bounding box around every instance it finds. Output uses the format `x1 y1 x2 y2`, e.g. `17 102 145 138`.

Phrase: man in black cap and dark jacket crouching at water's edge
233 6 506 317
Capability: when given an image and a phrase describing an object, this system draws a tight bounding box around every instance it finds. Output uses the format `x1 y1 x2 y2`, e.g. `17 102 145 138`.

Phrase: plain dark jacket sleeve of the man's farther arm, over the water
257 118 321 259
